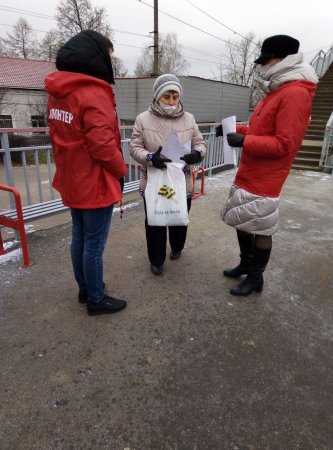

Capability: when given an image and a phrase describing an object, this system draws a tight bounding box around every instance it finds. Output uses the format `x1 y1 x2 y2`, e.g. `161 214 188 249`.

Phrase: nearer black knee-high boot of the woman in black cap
230 247 271 295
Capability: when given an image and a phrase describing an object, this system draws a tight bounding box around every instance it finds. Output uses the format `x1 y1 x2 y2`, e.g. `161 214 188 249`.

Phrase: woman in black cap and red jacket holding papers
217 35 318 295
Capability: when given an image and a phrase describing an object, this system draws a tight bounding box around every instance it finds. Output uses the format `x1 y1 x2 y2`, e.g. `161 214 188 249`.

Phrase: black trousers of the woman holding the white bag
144 198 192 266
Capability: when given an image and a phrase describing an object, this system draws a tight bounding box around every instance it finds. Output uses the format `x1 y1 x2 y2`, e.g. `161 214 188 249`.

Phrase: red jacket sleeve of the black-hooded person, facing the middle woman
82 88 127 179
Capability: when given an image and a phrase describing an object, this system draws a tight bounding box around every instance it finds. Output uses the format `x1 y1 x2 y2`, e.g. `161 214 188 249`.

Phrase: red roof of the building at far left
0 56 56 89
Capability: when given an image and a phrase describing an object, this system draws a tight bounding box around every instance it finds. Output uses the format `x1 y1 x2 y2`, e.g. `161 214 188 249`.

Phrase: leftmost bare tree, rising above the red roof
1 17 37 59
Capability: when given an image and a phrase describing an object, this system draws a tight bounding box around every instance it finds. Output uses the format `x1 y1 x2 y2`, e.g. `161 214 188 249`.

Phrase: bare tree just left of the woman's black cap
219 32 262 106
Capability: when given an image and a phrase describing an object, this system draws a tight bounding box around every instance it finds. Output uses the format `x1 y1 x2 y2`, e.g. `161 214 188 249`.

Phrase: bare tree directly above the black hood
56 0 112 42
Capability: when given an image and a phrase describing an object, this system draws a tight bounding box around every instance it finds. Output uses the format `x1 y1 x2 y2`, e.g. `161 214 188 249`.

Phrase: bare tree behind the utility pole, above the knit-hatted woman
135 33 190 77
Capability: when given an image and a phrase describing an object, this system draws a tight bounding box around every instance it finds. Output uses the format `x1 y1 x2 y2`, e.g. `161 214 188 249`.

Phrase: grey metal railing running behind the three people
0 123 231 209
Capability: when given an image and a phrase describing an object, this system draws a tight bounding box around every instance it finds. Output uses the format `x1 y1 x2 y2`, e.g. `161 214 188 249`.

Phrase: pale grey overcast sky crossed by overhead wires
0 0 333 78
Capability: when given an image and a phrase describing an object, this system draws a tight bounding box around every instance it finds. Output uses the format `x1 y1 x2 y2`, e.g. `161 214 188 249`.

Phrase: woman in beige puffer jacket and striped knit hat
130 74 206 275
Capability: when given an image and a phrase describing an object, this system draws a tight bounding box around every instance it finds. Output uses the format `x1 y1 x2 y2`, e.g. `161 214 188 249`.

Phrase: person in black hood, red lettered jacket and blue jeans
45 30 126 315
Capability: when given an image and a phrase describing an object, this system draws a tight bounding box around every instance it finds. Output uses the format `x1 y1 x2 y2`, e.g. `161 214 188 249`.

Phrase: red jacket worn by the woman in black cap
235 81 316 197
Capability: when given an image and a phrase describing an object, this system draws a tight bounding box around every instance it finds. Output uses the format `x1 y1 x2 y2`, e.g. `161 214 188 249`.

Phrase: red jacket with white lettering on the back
45 71 127 209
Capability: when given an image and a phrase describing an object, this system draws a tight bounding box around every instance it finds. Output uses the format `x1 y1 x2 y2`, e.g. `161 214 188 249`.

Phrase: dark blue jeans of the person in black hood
71 205 113 303
